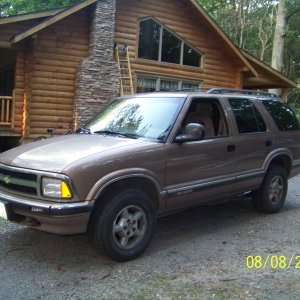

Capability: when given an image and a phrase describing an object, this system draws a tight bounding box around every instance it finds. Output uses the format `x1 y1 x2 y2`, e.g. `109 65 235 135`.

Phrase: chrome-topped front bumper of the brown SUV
0 190 93 235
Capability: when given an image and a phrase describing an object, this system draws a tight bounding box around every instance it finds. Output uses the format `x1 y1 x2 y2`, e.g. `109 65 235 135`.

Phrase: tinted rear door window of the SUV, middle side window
229 98 266 134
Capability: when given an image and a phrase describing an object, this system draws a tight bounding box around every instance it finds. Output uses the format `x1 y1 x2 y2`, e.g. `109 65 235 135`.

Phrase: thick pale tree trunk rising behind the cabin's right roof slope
270 0 286 96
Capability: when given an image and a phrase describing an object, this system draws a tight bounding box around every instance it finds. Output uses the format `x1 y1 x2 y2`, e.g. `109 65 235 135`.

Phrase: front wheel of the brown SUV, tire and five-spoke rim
91 189 156 261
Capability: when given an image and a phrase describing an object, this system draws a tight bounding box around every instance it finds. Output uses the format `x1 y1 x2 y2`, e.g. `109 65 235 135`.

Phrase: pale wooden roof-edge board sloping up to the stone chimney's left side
11 0 97 44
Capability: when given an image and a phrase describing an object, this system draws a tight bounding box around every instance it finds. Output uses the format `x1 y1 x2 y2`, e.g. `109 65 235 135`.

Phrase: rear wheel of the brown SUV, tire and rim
253 165 288 213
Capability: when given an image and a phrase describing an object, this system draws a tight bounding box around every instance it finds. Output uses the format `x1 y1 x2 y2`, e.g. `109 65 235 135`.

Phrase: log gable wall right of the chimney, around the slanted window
115 0 241 88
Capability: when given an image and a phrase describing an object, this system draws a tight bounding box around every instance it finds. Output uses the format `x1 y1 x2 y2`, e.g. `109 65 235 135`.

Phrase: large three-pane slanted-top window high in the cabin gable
138 19 202 67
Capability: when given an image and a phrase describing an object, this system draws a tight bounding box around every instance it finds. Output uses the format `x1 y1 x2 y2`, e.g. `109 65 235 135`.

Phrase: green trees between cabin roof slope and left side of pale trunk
198 0 275 62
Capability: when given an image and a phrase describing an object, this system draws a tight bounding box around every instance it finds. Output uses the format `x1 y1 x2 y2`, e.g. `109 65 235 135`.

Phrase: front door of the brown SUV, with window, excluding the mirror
166 99 236 210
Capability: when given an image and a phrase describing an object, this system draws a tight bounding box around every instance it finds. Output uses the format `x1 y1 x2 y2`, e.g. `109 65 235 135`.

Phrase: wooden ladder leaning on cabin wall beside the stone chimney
115 44 133 96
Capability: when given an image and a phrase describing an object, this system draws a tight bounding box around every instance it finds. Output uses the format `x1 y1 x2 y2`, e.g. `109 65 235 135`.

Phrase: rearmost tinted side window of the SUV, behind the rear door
262 100 300 131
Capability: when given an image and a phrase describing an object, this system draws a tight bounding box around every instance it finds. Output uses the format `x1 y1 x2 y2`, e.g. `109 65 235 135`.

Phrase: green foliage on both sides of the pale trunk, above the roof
197 0 300 82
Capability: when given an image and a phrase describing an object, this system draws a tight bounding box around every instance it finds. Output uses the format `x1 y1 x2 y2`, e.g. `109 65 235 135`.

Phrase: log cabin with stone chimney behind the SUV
0 0 296 151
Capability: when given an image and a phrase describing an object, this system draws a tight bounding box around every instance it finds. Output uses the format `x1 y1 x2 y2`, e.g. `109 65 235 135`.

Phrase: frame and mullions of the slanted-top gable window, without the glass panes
136 17 204 69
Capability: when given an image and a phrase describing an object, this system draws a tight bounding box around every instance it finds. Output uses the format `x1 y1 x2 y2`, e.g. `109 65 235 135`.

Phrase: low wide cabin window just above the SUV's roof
136 75 200 93
